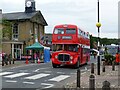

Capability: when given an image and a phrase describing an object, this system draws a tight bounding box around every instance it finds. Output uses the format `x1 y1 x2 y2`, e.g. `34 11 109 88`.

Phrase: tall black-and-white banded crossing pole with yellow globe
96 0 101 75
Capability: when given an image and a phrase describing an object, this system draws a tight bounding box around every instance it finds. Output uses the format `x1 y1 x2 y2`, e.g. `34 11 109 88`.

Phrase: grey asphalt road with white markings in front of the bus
0 57 96 90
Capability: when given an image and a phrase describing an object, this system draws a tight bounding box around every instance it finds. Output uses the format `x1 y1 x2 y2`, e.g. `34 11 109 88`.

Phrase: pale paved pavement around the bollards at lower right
65 64 120 90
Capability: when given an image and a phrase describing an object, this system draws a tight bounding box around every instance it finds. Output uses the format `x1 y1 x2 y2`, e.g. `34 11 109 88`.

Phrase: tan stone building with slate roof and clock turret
2 0 48 58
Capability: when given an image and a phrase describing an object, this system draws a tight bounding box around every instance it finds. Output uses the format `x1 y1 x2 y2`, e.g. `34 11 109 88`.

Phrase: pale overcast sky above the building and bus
0 0 120 38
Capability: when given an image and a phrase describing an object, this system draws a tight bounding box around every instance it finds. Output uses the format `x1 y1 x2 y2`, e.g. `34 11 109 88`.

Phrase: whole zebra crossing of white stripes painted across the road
0 72 70 84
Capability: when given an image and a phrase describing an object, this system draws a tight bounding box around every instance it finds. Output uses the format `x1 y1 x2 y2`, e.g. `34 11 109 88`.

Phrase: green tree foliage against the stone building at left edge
2 19 12 40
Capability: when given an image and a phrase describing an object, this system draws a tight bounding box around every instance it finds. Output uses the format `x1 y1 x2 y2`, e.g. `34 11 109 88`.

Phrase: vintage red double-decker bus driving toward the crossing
51 24 90 68
